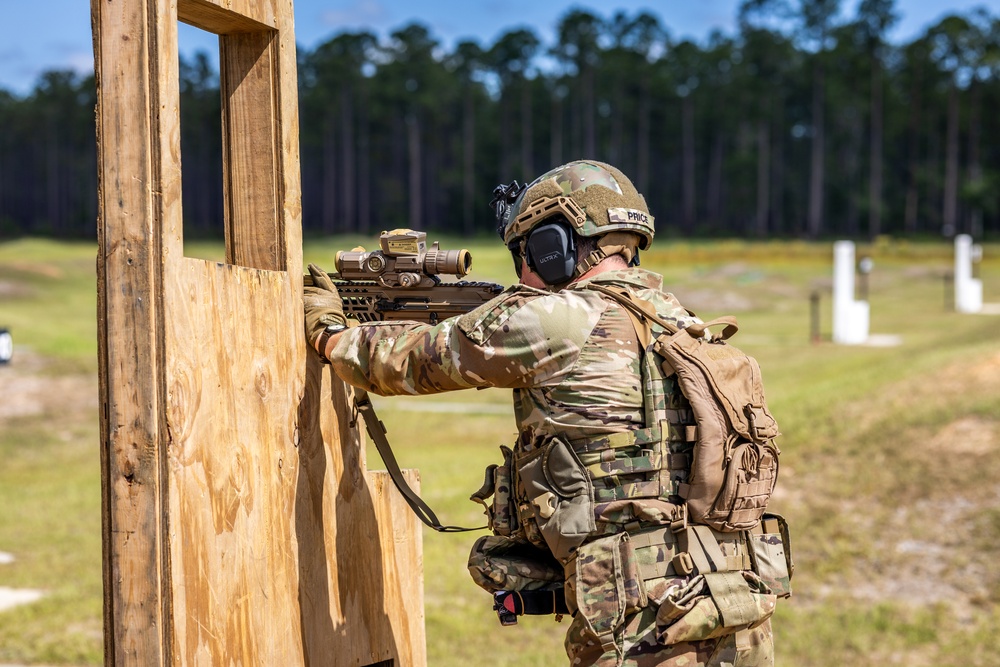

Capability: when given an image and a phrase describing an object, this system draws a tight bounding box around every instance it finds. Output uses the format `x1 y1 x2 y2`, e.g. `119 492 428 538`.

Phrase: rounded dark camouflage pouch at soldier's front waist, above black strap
469 535 564 593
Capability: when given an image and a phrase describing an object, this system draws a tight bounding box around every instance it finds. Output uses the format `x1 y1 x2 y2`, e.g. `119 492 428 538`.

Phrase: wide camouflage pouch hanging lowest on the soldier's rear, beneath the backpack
656 571 777 646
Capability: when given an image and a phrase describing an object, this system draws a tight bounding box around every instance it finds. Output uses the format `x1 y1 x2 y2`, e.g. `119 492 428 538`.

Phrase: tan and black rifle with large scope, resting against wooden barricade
304 229 503 324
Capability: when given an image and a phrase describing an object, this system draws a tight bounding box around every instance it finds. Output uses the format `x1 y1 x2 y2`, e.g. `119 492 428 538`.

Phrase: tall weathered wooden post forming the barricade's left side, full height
91 0 180 665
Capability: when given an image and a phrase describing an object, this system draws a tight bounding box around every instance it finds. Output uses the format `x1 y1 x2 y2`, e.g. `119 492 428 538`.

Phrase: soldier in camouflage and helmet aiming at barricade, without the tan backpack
305 161 774 667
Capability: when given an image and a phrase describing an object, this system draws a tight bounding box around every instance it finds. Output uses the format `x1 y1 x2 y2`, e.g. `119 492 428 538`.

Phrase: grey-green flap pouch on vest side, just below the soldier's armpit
515 438 597 564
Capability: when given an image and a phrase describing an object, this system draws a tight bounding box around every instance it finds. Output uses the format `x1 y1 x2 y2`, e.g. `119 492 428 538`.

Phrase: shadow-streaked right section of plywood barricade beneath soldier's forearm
296 363 427 666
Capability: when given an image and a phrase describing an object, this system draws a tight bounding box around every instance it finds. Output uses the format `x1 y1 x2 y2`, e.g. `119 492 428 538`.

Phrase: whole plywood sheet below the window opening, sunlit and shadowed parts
166 259 426 666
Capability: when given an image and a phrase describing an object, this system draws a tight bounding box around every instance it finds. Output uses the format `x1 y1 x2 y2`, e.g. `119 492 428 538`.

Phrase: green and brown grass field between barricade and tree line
0 238 1000 667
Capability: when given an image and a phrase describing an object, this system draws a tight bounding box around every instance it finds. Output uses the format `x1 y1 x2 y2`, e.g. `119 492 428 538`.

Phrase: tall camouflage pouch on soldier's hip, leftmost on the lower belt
566 533 648 650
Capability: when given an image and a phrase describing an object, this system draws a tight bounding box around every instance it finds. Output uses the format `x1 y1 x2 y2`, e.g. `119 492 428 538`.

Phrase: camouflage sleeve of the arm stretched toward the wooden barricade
330 288 603 395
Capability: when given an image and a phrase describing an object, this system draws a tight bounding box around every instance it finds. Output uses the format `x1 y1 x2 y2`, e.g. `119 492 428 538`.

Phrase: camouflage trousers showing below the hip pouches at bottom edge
566 606 774 667
